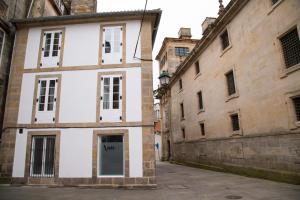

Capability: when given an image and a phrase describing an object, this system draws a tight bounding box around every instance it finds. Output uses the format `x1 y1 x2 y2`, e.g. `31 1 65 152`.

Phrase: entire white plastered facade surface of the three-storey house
13 18 143 178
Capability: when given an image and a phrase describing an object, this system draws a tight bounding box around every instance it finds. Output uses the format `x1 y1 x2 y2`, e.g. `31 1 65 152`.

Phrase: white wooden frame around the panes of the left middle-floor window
34 77 59 123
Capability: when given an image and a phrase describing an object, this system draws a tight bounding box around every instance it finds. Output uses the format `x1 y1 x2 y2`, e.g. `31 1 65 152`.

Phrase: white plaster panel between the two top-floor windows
63 23 100 66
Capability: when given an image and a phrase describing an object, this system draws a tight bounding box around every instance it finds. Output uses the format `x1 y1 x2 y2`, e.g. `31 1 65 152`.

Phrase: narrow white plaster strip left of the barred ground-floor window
12 130 27 177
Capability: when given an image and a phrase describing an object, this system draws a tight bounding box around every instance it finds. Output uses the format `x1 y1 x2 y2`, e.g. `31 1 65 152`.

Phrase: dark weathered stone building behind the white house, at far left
0 0 70 141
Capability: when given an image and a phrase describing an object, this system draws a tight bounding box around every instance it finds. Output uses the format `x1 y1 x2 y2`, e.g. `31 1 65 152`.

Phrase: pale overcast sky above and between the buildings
97 0 229 89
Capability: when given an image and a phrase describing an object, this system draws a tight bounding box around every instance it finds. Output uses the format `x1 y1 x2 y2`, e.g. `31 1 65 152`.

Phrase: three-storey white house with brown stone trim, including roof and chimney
1 0 161 186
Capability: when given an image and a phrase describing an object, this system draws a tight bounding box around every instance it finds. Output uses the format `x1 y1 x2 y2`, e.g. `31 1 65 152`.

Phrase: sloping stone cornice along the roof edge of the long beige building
170 0 249 86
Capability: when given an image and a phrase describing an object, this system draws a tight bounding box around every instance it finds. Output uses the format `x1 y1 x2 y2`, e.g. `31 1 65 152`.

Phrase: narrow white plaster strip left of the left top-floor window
24 28 41 69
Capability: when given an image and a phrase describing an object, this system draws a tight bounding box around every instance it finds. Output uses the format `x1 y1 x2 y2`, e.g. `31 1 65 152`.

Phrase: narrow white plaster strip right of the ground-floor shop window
129 127 143 177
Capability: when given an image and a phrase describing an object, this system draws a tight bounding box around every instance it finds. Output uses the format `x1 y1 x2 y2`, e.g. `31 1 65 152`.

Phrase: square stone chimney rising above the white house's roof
71 0 97 15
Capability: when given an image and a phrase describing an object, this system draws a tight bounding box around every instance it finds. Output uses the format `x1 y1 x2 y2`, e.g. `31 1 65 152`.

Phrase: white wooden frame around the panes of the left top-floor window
39 29 63 68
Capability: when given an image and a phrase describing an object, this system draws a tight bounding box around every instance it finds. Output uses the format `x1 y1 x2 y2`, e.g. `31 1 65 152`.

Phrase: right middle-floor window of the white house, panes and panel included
98 74 123 122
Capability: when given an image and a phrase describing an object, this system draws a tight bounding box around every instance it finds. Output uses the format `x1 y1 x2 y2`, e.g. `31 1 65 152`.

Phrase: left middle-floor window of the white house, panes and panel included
35 78 58 123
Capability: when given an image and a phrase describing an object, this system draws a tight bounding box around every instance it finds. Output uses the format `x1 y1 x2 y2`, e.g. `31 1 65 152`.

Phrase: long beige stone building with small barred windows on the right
157 0 300 183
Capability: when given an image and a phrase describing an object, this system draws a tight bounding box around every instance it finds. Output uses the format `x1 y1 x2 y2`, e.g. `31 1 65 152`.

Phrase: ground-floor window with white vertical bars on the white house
30 136 55 177
